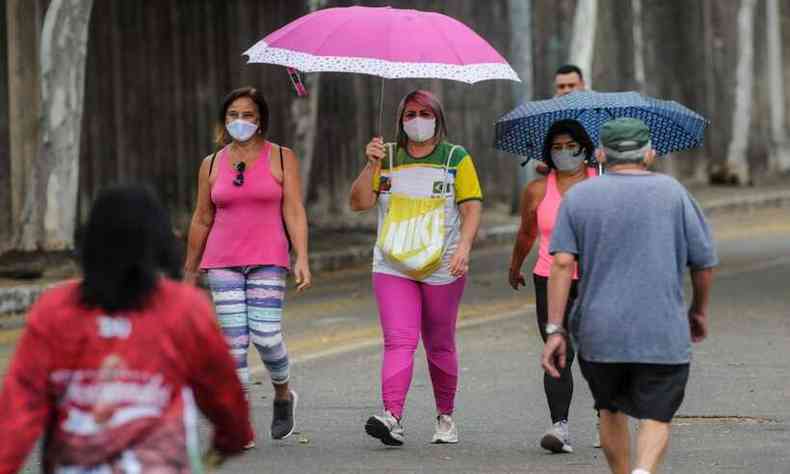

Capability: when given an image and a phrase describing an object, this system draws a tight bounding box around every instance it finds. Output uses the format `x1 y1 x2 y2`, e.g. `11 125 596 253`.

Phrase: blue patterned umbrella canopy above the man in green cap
494 91 708 161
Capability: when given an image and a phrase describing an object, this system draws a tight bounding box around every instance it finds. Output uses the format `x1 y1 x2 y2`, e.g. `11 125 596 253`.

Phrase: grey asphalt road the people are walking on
6 209 790 474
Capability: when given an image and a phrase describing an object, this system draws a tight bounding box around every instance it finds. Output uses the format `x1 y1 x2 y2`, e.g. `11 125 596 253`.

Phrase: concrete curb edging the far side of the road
0 190 790 317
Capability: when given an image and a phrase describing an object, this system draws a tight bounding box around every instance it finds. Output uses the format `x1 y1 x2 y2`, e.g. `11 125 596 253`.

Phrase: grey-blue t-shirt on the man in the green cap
549 173 718 364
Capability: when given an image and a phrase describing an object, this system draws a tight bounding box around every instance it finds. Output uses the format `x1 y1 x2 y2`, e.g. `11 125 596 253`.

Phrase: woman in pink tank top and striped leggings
184 87 311 448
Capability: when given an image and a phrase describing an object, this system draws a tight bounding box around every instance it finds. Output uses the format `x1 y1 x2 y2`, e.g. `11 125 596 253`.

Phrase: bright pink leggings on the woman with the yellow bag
373 273 466 418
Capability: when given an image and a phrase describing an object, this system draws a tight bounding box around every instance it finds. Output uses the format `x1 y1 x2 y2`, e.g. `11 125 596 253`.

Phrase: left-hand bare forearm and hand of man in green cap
542 252 576 378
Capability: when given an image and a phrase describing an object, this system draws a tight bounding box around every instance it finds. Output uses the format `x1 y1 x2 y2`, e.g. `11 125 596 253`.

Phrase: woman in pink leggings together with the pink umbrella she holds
244 2 519 445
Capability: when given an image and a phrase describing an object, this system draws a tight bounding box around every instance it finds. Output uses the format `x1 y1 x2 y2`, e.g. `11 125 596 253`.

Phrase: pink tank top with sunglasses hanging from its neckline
200 142 289 268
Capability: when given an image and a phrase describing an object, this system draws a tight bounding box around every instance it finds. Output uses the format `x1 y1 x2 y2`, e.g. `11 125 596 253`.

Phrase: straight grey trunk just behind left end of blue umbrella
509 0 535 214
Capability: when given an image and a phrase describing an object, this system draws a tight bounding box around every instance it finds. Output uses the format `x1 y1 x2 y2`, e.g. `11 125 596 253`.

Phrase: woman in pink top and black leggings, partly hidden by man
509 120 596 453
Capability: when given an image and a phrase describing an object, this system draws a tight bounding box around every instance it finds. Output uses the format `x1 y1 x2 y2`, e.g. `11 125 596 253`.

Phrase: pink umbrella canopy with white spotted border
244 6 519 84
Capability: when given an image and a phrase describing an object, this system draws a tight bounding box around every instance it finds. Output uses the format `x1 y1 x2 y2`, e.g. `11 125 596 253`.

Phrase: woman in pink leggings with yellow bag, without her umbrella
351 90 483 446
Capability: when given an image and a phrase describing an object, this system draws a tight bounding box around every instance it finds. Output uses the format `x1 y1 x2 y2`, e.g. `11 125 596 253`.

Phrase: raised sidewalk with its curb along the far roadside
0 178 790 318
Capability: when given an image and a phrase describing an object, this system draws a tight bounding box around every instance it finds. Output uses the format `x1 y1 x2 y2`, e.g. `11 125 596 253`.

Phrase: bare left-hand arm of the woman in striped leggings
184 156 216 284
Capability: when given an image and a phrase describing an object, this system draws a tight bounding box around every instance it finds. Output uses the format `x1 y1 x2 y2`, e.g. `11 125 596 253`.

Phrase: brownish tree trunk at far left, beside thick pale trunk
5 0 41 253
